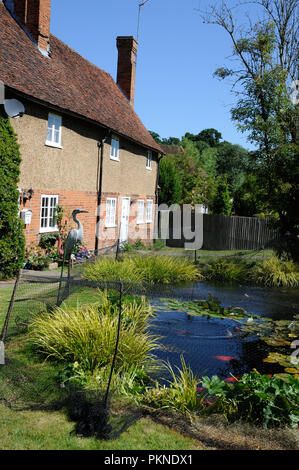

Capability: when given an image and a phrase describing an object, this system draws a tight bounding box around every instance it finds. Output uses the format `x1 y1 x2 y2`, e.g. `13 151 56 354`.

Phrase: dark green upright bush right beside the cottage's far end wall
159 157 182 206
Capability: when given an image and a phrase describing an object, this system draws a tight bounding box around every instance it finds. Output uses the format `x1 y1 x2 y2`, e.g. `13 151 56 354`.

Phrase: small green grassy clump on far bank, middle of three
203 257 248 283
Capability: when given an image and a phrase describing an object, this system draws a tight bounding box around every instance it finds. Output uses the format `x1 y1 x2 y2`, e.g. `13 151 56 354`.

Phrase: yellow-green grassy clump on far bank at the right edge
252 256 299 287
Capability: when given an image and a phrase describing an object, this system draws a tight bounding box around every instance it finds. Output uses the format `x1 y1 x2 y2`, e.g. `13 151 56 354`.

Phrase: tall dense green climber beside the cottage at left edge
0 116 25 278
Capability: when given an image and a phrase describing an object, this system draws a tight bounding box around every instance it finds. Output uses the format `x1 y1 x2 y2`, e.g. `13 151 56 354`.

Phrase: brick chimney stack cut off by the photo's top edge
4 0 51 52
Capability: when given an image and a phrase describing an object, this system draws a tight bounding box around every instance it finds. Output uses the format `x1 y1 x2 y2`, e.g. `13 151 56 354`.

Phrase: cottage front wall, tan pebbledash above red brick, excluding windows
11 96 158 250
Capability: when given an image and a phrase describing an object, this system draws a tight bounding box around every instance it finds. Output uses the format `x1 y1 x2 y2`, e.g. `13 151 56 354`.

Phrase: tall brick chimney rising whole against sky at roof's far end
116 36 138 107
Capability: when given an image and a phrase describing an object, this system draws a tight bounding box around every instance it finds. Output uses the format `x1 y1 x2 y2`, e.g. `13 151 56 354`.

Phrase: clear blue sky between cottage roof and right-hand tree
19 0 258 148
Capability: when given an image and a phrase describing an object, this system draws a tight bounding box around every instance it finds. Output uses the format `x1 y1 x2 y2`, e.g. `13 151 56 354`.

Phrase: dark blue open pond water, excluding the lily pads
151 283 299 383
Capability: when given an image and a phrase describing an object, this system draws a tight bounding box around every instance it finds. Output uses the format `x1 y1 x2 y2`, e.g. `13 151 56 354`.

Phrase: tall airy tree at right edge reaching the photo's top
205 0 299 259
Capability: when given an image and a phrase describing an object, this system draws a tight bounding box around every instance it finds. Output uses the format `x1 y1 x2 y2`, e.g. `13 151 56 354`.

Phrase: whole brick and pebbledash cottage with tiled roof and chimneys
0 0 163 250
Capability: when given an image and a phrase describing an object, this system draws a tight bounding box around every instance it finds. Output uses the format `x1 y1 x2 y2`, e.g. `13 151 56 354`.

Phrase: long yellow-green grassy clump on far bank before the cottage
83 255 201 284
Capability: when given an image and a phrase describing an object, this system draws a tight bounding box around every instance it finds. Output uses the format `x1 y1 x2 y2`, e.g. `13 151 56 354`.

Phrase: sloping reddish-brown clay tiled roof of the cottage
0 3 162 152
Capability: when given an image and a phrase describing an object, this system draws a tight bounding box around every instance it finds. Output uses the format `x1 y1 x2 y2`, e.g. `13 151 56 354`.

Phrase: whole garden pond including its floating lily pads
150 282 299 383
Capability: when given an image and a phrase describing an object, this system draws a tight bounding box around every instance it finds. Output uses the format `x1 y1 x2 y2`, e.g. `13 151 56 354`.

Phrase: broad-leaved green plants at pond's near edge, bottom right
202 371 299 428
